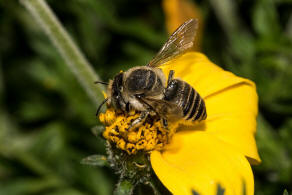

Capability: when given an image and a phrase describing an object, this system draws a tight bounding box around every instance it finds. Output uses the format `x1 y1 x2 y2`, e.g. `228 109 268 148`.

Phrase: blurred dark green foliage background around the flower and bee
0 0 292 195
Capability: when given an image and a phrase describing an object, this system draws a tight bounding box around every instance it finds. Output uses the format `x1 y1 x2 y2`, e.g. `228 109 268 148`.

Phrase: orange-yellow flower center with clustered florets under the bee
99 108 176 154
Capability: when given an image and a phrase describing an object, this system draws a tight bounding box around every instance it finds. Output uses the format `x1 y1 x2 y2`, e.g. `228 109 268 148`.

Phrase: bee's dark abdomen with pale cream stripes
164 79 207 121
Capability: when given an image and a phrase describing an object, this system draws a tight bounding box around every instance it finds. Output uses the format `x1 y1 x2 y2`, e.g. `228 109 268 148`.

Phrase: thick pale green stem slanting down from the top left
20 0 104 104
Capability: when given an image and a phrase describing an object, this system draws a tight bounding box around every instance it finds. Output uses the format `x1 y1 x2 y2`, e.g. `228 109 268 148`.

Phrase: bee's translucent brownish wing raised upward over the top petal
147 19 198 67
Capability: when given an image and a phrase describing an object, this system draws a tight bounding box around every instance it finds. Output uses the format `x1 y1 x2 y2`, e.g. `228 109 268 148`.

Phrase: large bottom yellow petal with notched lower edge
150 131 254 195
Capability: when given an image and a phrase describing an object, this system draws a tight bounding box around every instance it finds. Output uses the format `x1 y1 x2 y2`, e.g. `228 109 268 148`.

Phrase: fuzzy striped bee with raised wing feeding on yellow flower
96 19 207 128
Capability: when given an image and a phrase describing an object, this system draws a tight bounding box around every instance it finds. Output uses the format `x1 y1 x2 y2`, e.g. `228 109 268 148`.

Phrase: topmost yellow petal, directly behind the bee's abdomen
162 52 252 98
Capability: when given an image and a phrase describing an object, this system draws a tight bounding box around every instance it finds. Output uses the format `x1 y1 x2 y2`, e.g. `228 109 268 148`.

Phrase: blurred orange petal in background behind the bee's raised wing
162 0 203 50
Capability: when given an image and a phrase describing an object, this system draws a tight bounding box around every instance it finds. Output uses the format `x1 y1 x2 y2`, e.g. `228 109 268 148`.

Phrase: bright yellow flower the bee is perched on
101 52 261 195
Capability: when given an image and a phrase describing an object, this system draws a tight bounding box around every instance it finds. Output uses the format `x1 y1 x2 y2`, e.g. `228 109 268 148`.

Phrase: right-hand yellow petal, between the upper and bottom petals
204 84 261 164
